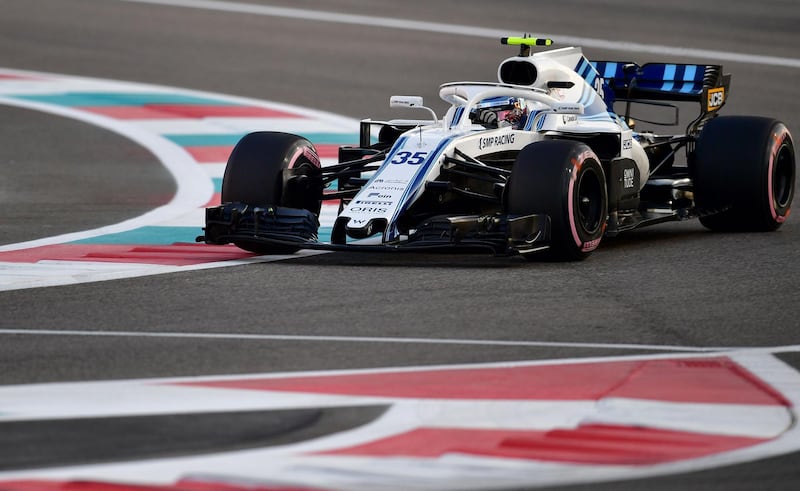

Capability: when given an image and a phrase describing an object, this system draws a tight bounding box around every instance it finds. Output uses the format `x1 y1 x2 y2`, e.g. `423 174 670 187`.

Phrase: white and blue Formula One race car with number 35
198 37 795 260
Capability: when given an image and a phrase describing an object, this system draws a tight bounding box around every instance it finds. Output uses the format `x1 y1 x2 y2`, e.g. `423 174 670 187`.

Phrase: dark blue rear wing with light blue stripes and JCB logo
592 61 731 133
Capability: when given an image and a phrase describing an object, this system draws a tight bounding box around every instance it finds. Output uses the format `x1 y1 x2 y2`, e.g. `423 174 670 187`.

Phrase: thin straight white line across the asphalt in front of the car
0 329 780 353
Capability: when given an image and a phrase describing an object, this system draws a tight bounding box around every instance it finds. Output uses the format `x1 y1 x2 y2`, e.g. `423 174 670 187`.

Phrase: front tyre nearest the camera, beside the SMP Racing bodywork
505 140 608 261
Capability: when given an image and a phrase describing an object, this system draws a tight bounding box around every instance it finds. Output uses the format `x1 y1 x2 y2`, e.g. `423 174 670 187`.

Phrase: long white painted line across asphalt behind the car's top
121 0 800 68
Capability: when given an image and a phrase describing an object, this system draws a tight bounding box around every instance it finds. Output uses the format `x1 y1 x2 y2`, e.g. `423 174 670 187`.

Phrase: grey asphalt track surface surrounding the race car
0 0 800 490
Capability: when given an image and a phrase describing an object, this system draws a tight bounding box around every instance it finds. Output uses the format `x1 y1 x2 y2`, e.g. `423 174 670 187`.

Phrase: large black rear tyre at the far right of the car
691 116 795 232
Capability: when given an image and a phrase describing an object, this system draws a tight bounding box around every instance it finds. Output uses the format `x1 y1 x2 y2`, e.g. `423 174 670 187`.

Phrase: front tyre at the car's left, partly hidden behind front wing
222 131 322 254
